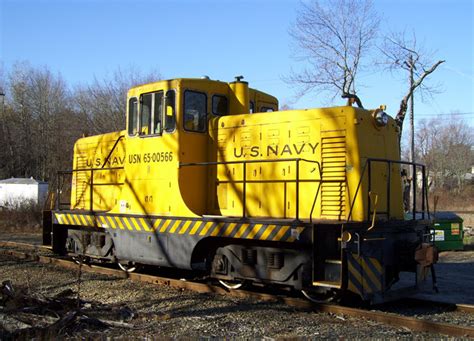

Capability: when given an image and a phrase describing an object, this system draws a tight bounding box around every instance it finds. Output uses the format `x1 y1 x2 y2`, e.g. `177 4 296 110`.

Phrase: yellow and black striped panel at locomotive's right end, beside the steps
347 254 384 297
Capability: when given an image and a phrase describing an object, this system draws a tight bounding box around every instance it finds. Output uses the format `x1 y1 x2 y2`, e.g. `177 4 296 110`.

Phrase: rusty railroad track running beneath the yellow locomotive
0 241 474 337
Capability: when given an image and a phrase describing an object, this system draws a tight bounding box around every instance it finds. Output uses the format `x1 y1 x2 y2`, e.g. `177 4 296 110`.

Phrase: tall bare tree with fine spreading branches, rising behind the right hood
288 0 380 98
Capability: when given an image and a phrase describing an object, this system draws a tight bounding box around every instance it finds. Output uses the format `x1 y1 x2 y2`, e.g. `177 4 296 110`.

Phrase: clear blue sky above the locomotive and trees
0 0 474 125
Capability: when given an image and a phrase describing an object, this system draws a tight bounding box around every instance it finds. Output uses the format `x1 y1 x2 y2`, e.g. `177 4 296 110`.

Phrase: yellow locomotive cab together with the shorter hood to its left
67 79 278 216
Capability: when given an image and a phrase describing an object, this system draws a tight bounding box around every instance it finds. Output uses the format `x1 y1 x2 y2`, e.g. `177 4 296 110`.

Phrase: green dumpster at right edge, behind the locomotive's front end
434 212 464 251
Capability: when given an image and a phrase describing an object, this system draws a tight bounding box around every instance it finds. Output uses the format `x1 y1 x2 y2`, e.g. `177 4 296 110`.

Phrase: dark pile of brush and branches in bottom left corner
0 280 135 340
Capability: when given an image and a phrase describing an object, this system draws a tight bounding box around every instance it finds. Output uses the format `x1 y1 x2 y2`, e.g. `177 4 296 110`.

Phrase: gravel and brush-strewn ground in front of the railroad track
0 255 456 339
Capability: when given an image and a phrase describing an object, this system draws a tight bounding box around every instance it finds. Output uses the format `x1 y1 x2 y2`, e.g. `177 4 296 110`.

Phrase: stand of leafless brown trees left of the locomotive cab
0 62 159 180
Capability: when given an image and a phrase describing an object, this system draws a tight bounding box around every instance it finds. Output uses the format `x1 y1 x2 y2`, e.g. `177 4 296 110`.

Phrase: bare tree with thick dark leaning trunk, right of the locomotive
381 32 445 137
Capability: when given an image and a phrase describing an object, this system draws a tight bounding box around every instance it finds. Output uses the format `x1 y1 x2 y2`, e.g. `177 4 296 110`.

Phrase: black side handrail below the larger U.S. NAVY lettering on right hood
179 158 322 221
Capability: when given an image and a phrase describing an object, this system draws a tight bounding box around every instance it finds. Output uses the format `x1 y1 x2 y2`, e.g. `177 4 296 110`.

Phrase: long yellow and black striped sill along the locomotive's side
54 212 305 242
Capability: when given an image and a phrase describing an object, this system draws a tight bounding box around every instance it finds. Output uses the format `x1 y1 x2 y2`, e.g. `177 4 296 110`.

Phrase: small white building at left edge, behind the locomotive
0 178 48 208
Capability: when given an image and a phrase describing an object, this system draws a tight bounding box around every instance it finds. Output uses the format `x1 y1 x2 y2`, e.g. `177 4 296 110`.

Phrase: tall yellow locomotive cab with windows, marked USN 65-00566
122 78 278 216
